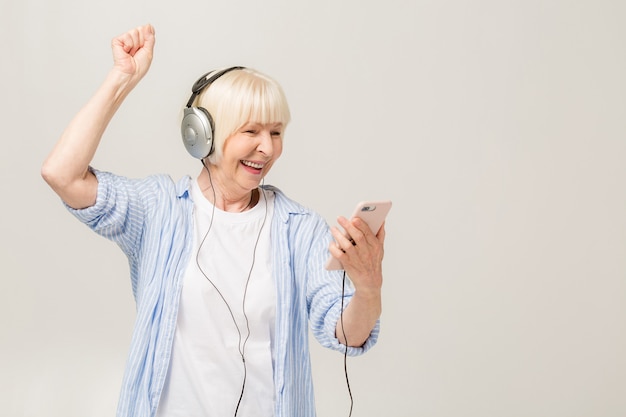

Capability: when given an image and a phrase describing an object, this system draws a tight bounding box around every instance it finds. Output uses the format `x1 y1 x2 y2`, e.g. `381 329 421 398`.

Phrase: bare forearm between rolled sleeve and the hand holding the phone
335 290 382 347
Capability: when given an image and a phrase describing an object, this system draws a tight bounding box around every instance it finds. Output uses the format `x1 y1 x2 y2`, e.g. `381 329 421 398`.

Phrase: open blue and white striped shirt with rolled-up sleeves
68 170 379 417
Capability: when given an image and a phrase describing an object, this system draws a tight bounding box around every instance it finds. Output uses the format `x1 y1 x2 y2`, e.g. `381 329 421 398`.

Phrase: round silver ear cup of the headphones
180 107 213 159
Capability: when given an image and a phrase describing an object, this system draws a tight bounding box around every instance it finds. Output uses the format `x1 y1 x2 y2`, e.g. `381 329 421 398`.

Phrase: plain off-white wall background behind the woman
0 0 626 417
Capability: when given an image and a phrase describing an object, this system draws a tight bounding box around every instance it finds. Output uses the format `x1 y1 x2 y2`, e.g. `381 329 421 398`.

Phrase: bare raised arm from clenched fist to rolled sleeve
41 25 155 209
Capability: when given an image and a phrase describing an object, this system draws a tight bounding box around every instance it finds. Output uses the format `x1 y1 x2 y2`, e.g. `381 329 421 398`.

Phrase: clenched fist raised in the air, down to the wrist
111 24 155 87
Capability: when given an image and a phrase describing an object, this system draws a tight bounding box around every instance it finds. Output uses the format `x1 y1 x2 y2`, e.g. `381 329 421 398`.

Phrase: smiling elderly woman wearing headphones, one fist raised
42 25 384 417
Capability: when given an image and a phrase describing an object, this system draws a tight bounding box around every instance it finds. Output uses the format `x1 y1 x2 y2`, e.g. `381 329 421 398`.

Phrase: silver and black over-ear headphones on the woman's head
180 67 244 159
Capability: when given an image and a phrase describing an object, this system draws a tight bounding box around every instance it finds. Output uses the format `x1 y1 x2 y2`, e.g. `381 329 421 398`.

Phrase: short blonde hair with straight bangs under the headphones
195 68 291 163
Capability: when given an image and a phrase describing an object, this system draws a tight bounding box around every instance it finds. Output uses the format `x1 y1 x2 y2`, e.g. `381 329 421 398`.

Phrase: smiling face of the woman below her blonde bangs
216 122 283 193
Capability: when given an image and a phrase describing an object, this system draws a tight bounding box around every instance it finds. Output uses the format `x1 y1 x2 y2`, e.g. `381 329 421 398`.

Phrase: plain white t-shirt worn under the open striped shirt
157 181 276 417
